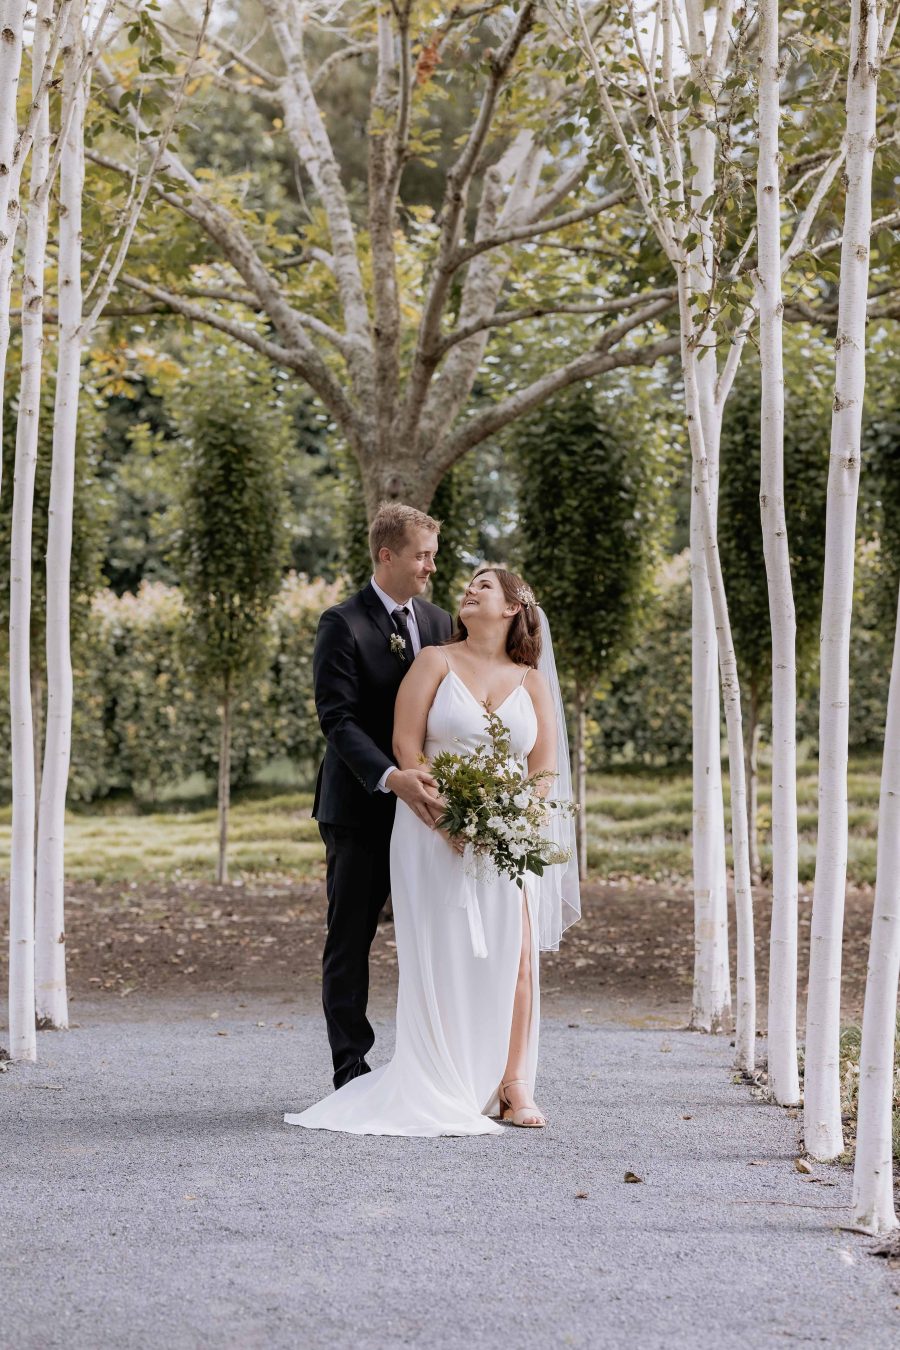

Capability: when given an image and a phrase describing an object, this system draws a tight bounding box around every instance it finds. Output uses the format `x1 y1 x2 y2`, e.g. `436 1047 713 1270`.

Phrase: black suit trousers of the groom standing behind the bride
318 821 391 1088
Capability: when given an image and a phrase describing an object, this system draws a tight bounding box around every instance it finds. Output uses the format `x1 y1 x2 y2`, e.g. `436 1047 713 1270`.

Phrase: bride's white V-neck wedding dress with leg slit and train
285 662 540 1135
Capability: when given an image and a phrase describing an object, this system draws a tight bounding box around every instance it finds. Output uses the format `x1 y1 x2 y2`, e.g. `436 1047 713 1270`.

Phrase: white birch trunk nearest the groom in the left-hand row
35 0 86 1029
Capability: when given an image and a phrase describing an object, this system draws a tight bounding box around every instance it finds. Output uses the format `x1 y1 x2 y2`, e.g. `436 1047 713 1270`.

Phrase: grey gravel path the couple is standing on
0 995 900 1350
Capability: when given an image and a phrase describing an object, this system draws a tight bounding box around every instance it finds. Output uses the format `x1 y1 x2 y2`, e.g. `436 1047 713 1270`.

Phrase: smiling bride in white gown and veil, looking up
285 567 580 1135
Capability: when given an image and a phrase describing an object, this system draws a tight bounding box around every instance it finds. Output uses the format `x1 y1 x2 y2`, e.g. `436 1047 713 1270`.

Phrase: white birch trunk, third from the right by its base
756 0 800 1106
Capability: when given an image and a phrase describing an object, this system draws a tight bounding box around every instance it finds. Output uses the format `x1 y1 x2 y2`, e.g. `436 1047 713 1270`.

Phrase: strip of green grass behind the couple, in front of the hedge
0 756 881 883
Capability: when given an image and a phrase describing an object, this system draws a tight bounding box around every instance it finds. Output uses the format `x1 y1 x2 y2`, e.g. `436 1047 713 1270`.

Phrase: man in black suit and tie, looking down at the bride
313 502 452 1088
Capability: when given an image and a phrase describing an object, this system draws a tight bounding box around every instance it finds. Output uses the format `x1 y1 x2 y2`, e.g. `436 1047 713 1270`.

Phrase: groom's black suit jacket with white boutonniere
313 582 453 829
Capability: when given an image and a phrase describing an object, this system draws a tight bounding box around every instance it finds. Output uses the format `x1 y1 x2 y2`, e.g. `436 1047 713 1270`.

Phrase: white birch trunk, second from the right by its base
803 0 880 1160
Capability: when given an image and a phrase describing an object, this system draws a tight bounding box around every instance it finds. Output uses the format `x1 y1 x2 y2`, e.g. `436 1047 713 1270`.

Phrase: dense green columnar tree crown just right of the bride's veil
515 381 668 691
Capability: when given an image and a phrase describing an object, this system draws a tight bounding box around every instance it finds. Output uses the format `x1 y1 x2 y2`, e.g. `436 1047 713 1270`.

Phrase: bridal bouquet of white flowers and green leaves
430 710 575 887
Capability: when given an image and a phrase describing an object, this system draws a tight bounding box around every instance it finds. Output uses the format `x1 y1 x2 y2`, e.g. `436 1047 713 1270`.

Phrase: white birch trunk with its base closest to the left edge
9 0 53 1060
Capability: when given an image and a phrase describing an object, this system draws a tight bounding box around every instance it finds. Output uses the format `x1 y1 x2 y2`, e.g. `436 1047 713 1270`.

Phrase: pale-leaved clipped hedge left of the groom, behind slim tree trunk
0 574 339 801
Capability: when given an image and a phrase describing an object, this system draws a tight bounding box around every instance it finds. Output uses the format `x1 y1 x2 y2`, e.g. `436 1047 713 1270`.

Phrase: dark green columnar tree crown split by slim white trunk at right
718 342 833 703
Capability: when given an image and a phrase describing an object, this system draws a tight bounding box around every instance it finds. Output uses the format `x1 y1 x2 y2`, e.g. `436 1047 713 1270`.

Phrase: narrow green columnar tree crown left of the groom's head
173 352 291 691
